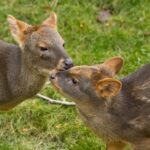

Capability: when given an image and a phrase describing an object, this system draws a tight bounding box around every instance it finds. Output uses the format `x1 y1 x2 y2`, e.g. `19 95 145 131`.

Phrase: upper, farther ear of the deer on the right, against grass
103 57 123 76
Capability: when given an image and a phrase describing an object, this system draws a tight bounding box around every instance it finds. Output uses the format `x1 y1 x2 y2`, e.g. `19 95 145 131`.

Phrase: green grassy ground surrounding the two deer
0 0 150 150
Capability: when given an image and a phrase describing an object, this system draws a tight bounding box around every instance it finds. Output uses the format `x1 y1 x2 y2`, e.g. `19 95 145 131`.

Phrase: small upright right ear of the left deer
42 12 57 30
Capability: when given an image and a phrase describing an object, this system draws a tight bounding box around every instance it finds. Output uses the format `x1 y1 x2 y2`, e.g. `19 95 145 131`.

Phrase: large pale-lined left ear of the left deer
7 15 31 47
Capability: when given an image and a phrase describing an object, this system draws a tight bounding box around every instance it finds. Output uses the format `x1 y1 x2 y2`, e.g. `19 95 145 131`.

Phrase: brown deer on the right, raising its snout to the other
51 57 150 150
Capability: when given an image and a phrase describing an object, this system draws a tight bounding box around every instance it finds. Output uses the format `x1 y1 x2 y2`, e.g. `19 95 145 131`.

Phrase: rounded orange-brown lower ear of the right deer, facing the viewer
96 78 122 98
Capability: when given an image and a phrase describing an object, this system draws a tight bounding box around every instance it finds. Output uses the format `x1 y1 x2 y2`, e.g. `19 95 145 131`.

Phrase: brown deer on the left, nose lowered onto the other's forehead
0 13 72 110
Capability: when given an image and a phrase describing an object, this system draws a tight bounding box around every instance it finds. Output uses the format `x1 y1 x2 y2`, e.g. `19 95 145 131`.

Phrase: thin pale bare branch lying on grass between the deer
36 94 75 106
